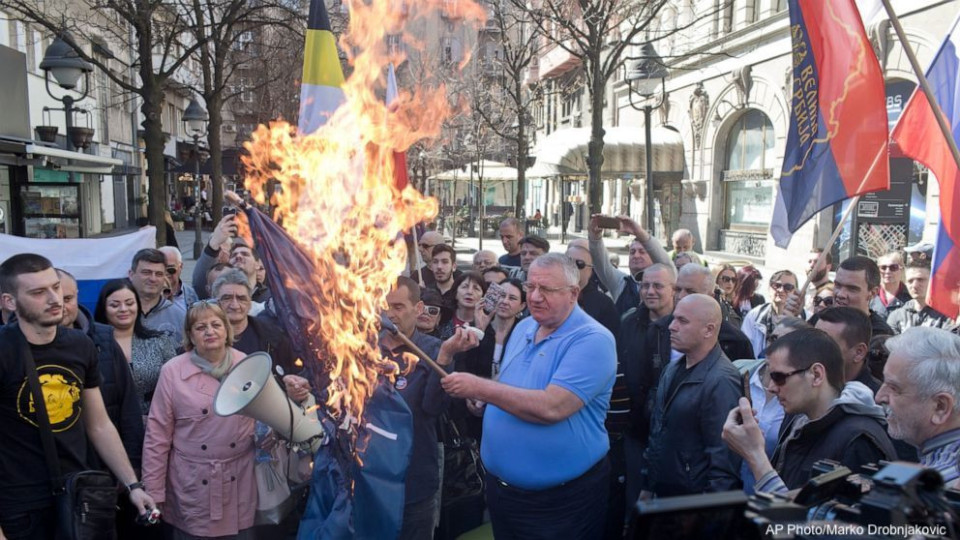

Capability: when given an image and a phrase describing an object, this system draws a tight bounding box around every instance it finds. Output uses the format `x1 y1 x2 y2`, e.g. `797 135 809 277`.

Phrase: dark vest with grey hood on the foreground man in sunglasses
772 385 896 489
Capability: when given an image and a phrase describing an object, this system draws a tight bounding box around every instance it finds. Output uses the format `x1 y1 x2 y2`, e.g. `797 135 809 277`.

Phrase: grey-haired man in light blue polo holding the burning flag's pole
442 253 617 540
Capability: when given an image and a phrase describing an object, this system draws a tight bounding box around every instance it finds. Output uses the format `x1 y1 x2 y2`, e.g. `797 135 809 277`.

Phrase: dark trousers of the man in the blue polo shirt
487 457 610 540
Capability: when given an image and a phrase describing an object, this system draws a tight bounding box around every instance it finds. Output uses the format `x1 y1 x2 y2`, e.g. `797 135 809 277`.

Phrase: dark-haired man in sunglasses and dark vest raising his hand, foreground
723 329 896 493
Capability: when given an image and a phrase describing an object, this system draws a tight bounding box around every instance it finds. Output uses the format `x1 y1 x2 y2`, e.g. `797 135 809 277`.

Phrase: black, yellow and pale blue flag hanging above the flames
297 0 343 135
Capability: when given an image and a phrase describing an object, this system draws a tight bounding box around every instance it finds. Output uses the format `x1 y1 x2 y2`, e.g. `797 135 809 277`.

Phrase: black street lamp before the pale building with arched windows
626 41 668 234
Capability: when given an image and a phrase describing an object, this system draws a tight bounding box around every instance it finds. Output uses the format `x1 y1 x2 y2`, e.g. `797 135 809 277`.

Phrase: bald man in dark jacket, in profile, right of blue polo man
641 294 743 498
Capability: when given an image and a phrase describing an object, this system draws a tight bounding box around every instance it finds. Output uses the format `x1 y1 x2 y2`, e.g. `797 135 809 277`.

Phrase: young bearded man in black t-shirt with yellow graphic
0 254 156 540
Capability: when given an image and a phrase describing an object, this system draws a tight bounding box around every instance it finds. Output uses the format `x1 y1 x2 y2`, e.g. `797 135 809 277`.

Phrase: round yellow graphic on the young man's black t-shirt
17 365 83 432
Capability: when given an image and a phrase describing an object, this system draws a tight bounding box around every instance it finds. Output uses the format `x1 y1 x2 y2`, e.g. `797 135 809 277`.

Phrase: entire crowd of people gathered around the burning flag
0 208 960 540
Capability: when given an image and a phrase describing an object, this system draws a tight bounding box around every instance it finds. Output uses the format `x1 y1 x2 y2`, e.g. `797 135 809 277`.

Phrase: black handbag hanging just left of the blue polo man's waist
440 415 485 506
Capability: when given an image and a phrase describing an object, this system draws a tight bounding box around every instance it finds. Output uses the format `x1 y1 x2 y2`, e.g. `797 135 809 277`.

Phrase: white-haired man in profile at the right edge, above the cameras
876 326 960 487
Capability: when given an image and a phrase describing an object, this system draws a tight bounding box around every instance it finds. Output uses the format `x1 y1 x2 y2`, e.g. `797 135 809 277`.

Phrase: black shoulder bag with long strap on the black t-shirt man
20 334 117 540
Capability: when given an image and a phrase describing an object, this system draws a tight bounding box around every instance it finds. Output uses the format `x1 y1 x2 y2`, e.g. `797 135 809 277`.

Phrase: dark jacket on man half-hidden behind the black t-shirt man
73 306 144 471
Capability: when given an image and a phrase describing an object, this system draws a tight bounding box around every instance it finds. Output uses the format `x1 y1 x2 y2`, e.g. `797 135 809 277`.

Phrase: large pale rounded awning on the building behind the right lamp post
527 126 684 178
